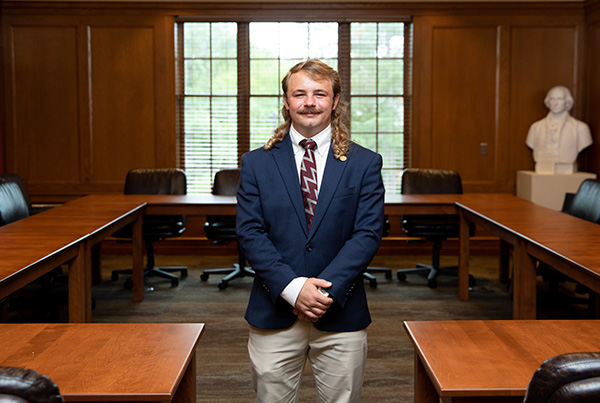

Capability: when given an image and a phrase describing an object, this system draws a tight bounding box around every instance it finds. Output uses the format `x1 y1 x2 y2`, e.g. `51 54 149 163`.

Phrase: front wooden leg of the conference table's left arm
68 241 92 323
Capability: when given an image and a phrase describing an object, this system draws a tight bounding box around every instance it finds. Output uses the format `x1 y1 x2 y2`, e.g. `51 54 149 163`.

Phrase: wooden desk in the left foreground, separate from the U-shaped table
0 323 204 403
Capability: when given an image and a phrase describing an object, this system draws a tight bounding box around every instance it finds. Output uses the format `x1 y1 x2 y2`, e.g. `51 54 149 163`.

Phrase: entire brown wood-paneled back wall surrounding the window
0 1 600 200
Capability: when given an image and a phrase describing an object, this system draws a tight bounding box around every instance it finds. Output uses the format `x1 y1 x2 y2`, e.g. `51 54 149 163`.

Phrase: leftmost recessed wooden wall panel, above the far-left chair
7 24 80 185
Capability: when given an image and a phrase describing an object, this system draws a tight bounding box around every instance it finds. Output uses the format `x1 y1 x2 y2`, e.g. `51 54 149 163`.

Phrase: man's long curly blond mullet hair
264 59 350 158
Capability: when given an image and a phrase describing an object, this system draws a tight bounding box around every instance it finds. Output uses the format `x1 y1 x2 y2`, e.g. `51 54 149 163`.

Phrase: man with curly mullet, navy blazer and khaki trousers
237 60 384 403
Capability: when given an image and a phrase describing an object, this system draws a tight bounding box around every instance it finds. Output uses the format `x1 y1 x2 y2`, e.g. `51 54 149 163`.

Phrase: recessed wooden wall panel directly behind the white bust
508 26 582 182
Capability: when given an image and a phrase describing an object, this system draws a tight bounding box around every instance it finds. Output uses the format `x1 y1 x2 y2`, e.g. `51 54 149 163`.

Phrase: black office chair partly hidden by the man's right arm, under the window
200 169 254 290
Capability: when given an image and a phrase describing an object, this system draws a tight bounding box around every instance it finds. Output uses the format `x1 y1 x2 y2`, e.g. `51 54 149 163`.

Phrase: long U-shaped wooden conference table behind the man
0 193 600 322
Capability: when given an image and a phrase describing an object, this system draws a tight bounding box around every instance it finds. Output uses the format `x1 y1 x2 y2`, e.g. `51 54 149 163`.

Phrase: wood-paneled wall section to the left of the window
3 10 175 199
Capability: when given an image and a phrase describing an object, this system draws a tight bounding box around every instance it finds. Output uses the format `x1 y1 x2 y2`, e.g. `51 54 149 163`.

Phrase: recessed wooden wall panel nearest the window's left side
90 26 156 183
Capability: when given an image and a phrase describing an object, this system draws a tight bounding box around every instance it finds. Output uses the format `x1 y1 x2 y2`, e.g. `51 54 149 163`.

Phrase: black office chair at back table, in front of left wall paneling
111 168 188 289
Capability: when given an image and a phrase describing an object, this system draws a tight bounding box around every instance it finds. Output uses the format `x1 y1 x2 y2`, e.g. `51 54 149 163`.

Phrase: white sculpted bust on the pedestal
525 86 592 174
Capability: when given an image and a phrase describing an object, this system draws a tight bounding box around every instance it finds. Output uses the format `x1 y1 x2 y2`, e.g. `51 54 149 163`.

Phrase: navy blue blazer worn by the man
237 135 385 331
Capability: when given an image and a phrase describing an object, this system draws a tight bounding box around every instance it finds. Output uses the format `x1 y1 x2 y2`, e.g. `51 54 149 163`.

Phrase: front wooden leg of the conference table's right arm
513 239 537 319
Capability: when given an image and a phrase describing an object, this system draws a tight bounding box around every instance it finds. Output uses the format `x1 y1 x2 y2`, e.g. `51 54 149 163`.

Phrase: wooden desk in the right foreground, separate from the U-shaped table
404 320 600 403
